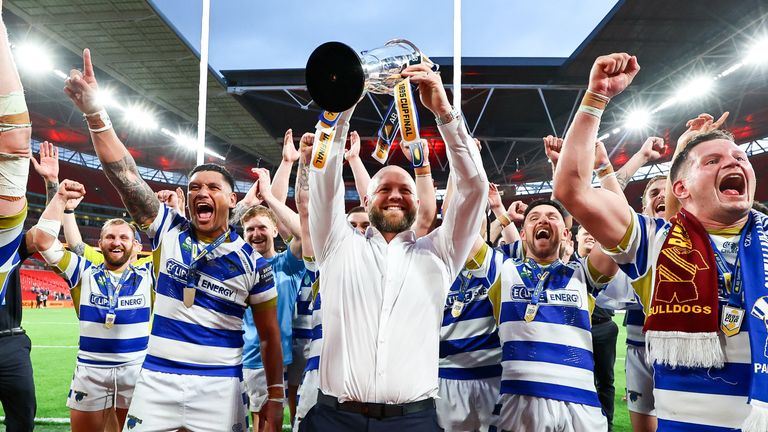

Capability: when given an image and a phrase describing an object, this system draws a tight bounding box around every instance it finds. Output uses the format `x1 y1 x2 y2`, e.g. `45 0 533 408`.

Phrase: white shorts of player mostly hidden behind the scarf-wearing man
624 345 656 416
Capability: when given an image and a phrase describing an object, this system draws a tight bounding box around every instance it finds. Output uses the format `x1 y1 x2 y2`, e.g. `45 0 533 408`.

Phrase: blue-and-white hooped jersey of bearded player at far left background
55 251 155 367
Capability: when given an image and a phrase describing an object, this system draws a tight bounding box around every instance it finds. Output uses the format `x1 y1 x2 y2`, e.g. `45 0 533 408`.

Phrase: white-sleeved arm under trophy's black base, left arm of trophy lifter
309 107 355 264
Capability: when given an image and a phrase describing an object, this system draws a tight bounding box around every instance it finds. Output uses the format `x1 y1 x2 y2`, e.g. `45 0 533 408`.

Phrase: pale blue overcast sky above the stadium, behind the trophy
150 0 616 70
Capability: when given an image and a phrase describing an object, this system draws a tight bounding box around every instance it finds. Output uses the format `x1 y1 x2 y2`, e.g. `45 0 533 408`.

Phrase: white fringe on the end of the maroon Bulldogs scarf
645 330 724 368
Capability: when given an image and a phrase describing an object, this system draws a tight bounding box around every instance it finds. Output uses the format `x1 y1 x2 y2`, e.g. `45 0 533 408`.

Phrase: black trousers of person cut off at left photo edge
0 334 37 432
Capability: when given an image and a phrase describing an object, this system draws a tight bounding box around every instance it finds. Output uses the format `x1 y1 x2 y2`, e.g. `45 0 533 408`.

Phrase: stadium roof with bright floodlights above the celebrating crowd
4 0 768 192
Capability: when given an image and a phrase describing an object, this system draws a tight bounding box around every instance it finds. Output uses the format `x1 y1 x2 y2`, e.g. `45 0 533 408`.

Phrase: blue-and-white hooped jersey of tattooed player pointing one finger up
143 205 277 377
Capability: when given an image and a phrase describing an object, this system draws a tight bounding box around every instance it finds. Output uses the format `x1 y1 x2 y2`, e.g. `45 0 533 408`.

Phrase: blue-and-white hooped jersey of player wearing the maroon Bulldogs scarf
606 214 766 432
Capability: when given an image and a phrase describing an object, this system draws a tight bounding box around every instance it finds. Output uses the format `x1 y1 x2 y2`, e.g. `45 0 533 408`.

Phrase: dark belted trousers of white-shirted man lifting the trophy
299 403 443 432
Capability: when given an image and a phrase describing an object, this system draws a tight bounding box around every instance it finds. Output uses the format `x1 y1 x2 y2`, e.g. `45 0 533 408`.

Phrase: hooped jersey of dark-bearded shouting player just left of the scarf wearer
491 260 600 407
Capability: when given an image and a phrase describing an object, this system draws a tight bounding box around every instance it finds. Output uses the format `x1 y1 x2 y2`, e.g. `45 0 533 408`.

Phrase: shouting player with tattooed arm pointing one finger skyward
64 49 283 432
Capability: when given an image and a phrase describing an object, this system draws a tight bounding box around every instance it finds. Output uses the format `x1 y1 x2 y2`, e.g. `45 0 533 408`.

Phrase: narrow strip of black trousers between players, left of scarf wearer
592 320 619 431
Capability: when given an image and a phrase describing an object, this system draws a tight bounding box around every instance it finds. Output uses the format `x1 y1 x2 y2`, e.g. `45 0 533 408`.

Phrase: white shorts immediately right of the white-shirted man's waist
435 377 501 432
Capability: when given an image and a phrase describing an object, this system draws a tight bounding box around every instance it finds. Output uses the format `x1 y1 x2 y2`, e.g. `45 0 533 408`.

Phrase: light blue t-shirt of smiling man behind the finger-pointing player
243 249 305 369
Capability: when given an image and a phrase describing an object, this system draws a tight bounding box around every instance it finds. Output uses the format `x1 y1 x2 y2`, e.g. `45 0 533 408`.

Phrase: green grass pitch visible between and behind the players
0 309 632 432
